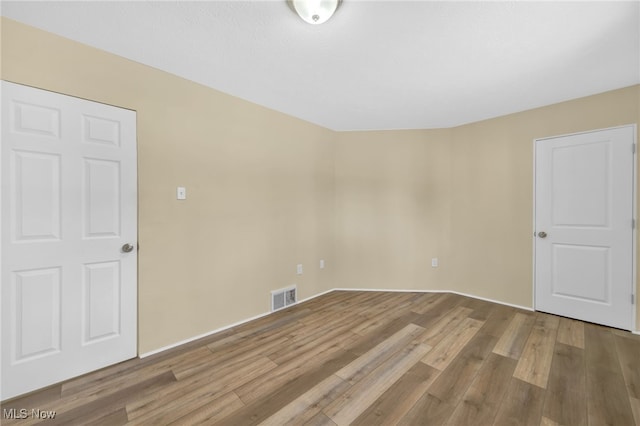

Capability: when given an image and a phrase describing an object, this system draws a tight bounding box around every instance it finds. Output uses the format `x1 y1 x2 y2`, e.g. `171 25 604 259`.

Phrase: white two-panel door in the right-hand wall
534 126 635 330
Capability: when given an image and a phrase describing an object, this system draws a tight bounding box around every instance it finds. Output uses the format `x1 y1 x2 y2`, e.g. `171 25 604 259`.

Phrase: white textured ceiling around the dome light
1 0 640 130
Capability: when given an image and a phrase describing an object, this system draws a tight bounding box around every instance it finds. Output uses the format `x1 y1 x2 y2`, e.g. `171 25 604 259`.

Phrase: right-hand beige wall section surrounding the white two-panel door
451 86 639 322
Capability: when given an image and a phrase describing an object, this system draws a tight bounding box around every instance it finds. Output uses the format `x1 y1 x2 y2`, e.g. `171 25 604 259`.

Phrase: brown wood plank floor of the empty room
1 291 640 426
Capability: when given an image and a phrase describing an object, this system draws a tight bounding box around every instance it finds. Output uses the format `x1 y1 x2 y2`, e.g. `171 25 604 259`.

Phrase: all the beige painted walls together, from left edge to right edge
1 18 640 353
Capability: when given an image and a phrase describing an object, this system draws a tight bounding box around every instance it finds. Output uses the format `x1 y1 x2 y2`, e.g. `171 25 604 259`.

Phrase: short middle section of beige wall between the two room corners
335 129 451 289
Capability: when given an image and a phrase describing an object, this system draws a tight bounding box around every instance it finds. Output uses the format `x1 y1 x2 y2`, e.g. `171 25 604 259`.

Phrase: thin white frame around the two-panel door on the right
531 123 640 334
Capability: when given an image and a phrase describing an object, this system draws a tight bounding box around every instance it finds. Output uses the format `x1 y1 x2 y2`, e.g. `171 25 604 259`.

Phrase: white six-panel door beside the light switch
0 82 137 400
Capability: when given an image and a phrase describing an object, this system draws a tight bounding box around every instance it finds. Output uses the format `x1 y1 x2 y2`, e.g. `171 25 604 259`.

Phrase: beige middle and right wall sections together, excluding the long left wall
335 86 640 329
